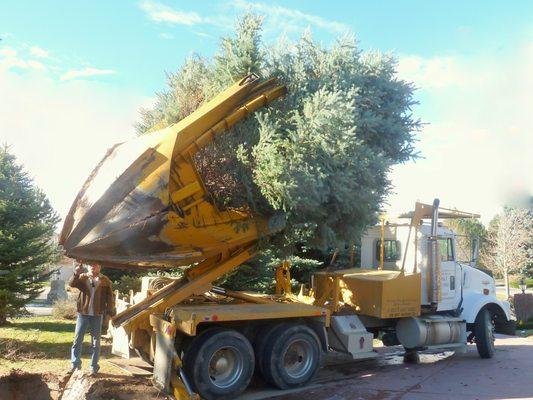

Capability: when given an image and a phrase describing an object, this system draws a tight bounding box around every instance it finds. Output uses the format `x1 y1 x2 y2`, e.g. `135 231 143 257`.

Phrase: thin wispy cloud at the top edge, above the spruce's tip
232 0 351 34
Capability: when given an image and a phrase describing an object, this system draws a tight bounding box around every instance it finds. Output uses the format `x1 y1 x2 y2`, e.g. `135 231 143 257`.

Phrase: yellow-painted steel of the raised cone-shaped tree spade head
61 75 286 267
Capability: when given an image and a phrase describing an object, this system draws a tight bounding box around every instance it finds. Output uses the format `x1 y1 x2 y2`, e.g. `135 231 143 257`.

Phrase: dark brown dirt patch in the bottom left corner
0 370 59 400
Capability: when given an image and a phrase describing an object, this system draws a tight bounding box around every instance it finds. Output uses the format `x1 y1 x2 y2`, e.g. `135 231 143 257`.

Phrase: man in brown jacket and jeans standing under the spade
69 264 115 375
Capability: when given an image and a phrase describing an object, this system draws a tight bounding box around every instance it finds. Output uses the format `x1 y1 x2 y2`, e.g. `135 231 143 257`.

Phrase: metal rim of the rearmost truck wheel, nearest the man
209 347 244 389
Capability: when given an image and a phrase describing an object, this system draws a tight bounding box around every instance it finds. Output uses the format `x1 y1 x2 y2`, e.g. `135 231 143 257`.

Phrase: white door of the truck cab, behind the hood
437 236 461 311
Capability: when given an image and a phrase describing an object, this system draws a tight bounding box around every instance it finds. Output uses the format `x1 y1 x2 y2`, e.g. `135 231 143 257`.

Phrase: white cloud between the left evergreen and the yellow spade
0 71 146 223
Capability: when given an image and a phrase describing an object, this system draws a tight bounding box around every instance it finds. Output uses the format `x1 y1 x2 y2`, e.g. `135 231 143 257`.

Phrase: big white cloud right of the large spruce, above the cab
389 43 533 222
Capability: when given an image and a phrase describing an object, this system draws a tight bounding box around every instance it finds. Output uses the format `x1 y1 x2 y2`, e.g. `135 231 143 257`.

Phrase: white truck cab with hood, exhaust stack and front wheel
361 200 514 358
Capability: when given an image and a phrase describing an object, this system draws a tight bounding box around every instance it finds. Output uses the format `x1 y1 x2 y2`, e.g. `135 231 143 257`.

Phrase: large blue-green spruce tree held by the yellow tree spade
137 14 420 288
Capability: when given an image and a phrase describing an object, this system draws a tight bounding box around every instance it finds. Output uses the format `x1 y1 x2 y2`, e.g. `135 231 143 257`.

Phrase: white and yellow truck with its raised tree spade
60 75 512 399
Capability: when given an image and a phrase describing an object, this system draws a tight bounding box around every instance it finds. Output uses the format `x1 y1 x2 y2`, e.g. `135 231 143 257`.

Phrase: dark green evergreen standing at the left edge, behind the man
0 146 59 325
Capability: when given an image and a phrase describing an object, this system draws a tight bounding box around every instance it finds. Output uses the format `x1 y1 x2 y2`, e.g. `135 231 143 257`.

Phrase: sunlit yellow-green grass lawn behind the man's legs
0 317 124 376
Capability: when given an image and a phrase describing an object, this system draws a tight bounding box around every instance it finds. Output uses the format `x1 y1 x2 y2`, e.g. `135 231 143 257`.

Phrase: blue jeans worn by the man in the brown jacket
70 314 102 372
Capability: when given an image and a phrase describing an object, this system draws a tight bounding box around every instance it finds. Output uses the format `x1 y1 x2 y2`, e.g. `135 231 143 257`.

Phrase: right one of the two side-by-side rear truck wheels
261 324 321 389
